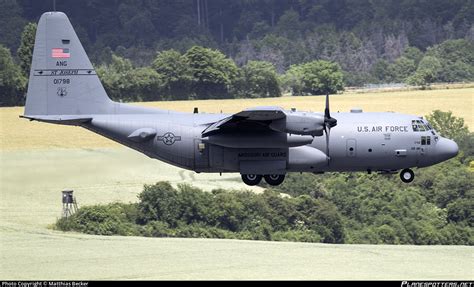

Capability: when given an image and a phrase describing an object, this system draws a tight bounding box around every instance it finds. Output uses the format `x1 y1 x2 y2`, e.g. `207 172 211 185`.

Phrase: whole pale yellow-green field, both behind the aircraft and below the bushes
0 88 474 280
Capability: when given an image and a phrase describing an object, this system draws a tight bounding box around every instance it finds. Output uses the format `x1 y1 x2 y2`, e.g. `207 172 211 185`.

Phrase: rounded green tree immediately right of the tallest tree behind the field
236 61 281 98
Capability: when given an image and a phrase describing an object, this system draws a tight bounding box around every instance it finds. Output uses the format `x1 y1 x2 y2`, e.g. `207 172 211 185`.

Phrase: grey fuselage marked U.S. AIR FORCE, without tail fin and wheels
83 111 457 175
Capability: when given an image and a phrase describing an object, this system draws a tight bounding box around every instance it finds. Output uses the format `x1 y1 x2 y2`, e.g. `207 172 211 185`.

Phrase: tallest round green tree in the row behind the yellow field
184 46 238 99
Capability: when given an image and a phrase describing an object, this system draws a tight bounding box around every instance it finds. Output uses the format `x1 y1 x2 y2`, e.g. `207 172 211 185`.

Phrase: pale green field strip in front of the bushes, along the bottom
0 228 473 280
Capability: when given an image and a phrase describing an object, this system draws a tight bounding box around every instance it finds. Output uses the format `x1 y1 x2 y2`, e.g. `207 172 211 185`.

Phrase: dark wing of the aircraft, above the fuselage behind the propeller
202 107 286 137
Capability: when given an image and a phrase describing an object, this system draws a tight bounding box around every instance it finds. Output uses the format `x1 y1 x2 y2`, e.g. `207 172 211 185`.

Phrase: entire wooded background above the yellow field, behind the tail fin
0 0 474 106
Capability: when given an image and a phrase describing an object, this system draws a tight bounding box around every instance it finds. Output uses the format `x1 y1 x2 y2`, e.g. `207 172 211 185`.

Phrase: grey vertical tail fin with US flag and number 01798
25 12 113 116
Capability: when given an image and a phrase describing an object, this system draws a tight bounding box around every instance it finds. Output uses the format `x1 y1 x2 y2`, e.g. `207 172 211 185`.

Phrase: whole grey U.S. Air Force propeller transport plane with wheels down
21 12 458 185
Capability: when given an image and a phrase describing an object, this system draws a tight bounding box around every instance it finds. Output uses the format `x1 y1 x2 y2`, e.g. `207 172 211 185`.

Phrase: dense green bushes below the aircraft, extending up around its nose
54 111 474 245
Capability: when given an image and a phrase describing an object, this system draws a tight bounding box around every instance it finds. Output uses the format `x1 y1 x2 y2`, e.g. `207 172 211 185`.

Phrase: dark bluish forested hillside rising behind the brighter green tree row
0 0 474 69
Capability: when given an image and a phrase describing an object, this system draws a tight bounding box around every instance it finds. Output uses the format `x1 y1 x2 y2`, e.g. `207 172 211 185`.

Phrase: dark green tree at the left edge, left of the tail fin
0 45 26 106
